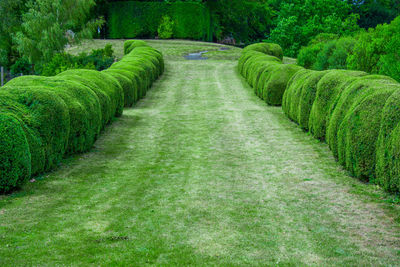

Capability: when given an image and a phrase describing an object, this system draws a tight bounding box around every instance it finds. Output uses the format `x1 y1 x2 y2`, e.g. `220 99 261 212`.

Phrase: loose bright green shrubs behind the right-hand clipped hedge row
298 17 400 81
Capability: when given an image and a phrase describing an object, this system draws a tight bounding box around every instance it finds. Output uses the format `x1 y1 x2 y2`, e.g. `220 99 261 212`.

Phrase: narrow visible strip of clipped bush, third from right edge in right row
326 75 396 158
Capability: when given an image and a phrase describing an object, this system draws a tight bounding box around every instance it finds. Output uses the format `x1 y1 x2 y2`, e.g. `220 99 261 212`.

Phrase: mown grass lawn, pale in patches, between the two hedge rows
0 41 400 266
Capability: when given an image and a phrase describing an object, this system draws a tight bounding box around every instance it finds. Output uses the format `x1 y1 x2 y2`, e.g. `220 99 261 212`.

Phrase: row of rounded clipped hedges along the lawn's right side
239 44 400 192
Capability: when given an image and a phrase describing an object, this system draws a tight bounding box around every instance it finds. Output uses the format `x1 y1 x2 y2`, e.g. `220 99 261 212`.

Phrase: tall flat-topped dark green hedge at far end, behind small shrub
108 1 212 41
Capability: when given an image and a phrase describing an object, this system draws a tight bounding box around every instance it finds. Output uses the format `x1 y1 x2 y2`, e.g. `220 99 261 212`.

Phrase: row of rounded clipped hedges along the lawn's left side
0 42 164 193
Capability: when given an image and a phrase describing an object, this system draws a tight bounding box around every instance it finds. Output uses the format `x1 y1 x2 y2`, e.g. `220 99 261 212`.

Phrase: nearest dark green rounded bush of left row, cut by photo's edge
0 112 31 193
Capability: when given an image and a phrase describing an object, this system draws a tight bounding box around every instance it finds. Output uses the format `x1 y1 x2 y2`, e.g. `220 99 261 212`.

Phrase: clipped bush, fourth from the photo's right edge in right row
308 70 366 140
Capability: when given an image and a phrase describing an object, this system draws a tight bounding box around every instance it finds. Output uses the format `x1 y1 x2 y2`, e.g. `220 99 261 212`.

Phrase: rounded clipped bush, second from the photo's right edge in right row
338 83 400 180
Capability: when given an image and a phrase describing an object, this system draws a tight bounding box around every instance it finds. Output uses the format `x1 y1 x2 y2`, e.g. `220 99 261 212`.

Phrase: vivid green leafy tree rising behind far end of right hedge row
268 0 359 57
